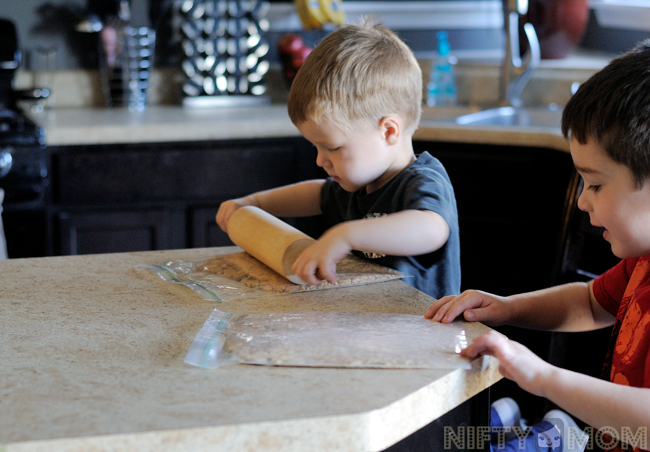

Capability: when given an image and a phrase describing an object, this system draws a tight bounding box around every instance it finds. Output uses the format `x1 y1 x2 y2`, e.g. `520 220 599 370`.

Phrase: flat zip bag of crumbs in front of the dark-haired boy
185 309 470 369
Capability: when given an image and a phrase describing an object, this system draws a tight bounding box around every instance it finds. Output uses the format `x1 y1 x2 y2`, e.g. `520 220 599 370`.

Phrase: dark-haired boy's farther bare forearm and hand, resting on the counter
424 282 615 331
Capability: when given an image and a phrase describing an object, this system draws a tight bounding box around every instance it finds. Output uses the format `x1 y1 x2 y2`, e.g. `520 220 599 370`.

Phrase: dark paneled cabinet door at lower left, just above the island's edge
58 210 183 254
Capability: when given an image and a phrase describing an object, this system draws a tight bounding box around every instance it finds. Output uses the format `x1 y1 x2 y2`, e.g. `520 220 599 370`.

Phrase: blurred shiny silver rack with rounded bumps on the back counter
177 0 269 107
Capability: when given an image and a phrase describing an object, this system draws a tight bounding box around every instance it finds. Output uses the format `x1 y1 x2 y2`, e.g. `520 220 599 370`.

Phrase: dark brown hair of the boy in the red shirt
562 39 650 186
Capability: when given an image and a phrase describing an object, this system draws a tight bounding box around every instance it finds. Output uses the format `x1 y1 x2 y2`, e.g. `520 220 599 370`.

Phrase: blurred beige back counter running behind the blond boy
31 105 569 152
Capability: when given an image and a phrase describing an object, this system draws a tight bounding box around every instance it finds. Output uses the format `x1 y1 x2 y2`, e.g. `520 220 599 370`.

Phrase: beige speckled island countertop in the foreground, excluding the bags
0 248 501 452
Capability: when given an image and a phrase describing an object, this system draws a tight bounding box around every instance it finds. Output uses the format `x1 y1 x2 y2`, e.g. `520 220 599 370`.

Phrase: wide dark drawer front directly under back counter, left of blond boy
53 140 308 206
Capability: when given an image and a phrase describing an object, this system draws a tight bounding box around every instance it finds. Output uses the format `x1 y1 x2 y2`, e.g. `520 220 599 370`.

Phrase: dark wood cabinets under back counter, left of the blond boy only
41 137 318 257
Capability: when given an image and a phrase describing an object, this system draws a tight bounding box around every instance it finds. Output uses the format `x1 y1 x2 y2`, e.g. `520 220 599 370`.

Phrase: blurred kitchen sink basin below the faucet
455 107 562 127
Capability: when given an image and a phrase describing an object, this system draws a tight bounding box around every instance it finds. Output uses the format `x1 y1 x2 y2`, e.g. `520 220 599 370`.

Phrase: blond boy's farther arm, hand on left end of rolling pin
216 179 325 232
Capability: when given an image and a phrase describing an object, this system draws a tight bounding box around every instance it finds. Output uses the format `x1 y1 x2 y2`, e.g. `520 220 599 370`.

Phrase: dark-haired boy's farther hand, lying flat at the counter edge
424 290 508 325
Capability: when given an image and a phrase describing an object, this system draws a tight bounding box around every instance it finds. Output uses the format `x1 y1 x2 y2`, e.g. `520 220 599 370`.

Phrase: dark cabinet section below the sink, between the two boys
415 142 575 295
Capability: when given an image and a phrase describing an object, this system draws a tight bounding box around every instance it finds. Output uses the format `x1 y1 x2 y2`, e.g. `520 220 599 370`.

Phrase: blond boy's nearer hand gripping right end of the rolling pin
292 223 352 285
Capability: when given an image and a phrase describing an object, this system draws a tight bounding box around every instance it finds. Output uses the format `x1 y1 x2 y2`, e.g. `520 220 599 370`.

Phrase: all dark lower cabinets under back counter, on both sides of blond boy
5 137 573 295
